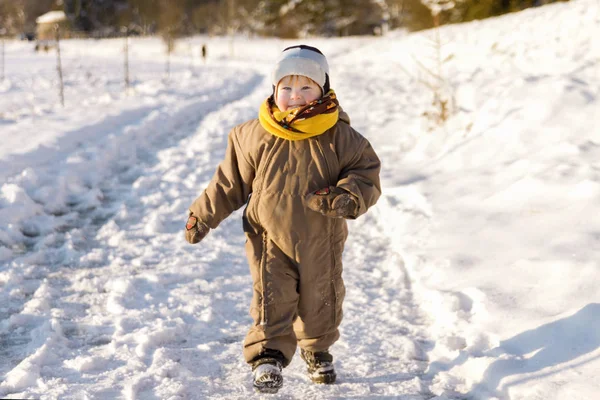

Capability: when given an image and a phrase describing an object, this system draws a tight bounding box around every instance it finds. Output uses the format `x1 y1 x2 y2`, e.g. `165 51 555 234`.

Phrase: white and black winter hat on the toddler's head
272 45 330 94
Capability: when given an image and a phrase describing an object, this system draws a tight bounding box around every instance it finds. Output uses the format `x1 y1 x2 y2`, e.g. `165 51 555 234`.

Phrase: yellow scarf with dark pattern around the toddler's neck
258 90 339 140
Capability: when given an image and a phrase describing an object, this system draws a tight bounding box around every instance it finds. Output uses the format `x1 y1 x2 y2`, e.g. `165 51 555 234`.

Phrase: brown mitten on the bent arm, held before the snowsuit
306 186 358 218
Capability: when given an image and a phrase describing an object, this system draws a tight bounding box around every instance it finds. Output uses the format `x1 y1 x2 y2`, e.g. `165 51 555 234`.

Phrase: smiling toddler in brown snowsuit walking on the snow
186 45 381 393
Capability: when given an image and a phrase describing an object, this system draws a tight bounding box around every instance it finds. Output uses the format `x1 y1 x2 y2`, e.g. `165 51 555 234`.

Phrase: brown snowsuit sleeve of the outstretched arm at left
190 127 255 229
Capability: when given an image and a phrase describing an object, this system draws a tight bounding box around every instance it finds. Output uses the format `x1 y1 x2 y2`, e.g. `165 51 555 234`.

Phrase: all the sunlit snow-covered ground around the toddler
0 0 600 400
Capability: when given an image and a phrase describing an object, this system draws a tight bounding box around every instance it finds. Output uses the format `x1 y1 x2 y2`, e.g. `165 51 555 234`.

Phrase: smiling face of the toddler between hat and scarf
275 75 321 111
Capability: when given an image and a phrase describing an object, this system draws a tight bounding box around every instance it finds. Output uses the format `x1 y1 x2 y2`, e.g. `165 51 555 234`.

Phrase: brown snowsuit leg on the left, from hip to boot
244 232 299 366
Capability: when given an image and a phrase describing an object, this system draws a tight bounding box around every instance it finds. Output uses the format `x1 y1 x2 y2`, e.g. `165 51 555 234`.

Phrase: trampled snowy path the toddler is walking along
0 43 446 399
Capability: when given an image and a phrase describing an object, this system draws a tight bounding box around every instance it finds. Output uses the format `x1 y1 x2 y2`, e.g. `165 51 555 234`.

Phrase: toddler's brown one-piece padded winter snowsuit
190 112 381 366
